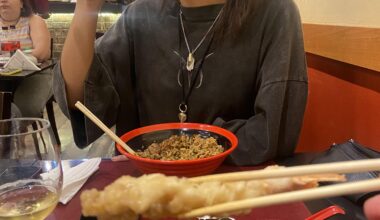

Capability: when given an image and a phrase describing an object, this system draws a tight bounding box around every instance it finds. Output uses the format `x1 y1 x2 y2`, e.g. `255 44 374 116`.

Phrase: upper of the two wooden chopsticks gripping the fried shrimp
189 159 380 182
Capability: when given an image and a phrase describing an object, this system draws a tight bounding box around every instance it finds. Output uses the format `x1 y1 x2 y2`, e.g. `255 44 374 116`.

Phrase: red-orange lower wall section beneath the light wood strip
297 54 380 152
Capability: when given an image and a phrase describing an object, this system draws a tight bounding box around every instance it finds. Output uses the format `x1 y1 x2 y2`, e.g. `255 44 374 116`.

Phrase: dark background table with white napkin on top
0 59 56 119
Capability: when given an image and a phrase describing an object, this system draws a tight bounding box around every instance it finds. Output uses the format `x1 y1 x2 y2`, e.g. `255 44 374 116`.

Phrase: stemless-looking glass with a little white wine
0 118 62 219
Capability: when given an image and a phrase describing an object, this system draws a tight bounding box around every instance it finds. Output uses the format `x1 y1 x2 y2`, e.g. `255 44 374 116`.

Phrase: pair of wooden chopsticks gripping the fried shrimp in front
178 159 380 218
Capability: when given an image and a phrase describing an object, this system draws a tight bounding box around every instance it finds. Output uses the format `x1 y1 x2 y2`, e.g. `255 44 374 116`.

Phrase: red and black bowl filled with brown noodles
116 123 237 177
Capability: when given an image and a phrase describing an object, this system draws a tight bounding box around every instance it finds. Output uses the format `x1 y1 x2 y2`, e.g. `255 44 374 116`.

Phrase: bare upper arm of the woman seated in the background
29 15 51 62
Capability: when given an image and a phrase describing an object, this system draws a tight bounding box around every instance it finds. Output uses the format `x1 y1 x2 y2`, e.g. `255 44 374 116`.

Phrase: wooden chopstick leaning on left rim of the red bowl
75 101 136 155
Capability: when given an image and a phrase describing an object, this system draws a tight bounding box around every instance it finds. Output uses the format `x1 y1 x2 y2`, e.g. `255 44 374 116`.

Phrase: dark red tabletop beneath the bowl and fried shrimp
47 160 311 220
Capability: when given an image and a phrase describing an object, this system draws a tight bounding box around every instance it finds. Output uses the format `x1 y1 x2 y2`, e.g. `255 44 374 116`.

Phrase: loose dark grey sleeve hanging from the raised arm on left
53 8 131 147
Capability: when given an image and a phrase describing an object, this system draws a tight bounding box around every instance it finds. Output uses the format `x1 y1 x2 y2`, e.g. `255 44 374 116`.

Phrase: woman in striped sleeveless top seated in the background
0 0 52 117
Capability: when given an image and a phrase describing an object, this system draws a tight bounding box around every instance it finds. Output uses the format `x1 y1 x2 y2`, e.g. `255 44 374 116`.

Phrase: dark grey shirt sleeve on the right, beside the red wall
214 0 308 165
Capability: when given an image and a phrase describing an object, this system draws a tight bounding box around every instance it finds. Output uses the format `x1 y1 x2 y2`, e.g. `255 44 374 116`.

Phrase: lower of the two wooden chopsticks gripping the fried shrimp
178 178 380 218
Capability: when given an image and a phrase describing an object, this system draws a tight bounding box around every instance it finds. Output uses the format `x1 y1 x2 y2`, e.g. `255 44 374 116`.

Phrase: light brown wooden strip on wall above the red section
303 24 380 71
